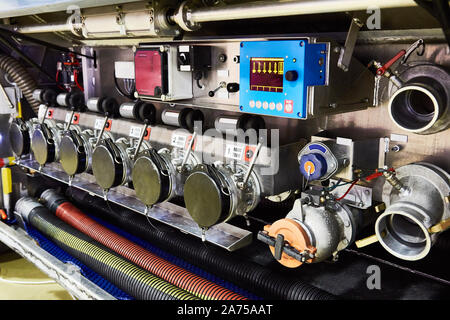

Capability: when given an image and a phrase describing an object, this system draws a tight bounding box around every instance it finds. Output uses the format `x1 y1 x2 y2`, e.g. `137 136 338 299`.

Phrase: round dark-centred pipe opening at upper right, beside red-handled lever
389 85 440 132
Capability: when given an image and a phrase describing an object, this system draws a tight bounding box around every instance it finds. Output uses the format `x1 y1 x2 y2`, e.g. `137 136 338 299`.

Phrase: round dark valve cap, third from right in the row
92 143 124 190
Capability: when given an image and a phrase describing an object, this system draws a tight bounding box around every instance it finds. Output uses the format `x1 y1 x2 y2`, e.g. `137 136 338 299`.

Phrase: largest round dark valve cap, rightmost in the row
184 166 230 227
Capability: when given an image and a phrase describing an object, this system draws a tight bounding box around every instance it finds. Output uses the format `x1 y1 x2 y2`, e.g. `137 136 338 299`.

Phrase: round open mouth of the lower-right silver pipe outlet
375 212 431 261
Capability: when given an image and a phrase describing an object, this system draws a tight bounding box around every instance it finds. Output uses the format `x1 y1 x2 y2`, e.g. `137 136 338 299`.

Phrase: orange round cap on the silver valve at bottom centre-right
264 218 315 268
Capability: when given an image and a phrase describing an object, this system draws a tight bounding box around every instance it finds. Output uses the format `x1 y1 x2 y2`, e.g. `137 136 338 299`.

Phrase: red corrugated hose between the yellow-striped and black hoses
41 189 246 300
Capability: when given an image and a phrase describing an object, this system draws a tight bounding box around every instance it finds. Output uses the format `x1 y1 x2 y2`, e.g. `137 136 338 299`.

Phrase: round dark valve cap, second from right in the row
132 153 171 206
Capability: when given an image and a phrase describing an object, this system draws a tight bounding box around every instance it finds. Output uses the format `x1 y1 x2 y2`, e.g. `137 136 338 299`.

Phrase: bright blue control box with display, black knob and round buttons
239 39 327 119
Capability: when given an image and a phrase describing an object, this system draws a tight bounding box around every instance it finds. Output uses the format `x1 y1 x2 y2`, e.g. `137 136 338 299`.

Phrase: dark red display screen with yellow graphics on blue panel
250 58 284 92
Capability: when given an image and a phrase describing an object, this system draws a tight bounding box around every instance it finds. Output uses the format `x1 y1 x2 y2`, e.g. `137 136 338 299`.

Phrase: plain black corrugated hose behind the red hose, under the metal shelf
72 190 335 300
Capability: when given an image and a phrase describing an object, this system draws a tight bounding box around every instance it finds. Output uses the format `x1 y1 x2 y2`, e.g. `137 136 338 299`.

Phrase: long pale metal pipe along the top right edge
186 0 417 23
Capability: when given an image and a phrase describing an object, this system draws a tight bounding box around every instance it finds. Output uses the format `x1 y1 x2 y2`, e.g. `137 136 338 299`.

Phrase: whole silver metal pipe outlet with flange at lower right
375 162 450 261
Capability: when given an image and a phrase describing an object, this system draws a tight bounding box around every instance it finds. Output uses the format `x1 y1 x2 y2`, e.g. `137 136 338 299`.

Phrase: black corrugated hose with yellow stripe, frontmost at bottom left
16 197 199 300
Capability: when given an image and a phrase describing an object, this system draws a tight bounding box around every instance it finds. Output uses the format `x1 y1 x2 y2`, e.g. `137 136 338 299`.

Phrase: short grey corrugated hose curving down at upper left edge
0 54 39 114
